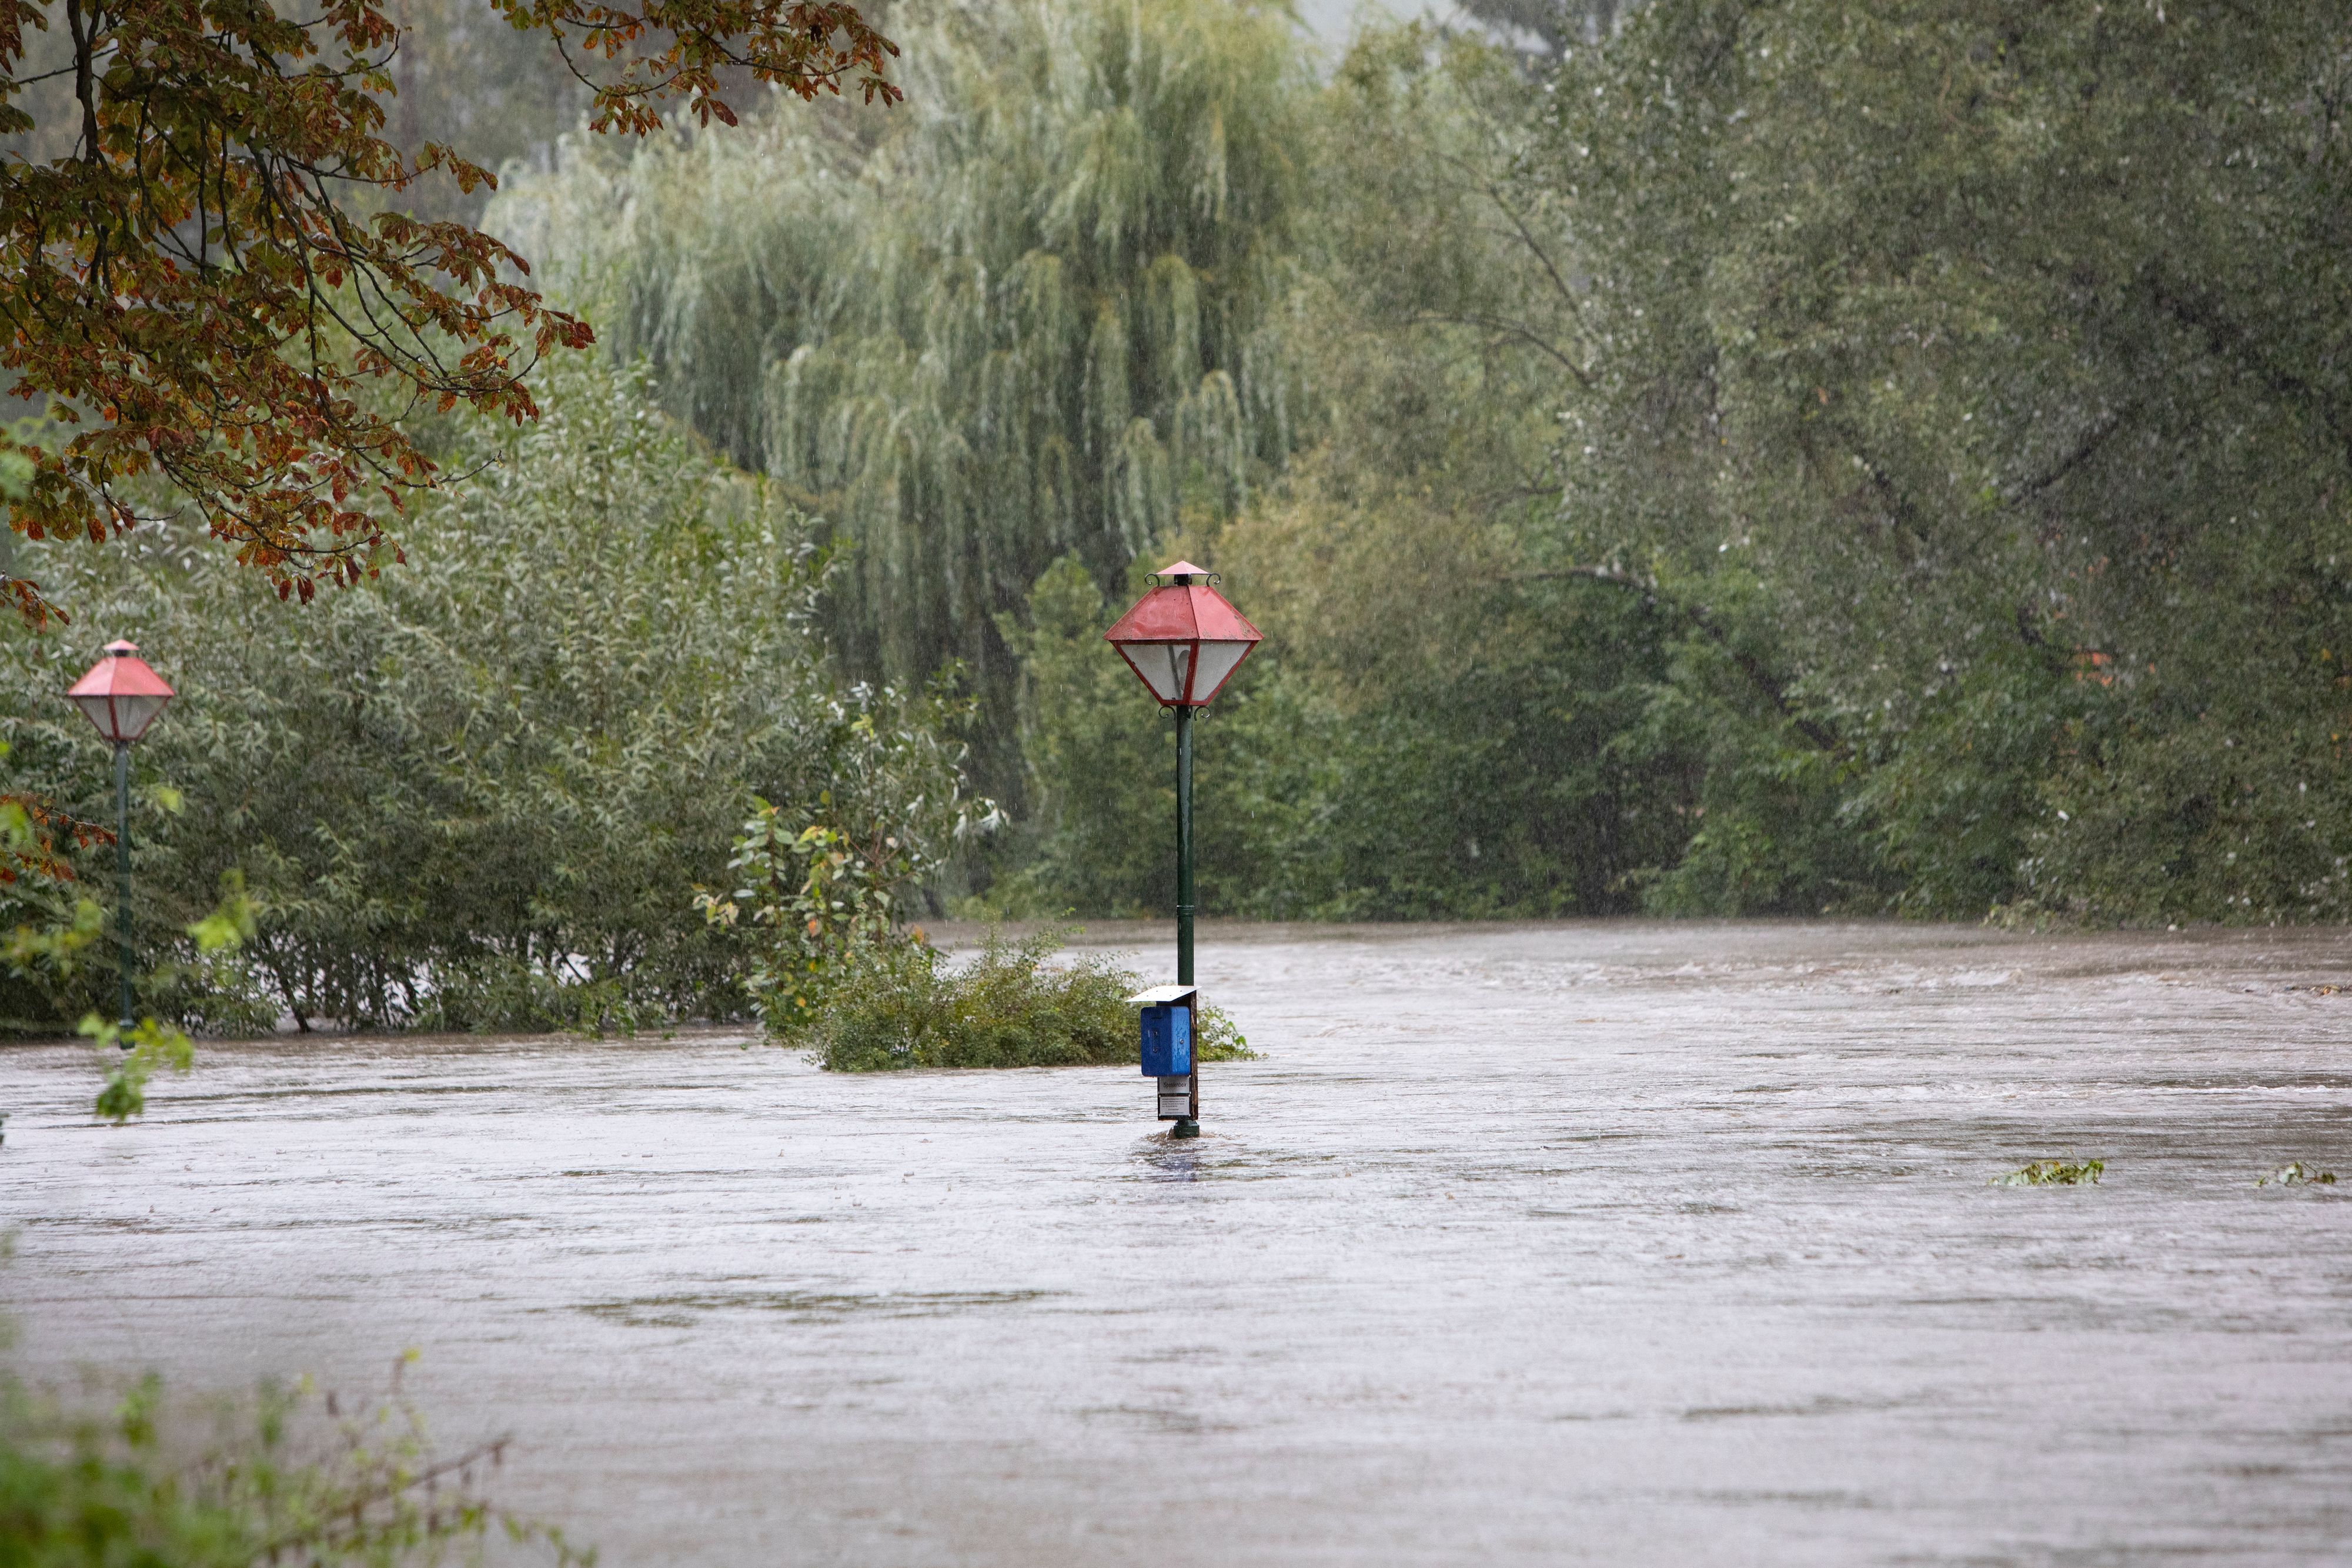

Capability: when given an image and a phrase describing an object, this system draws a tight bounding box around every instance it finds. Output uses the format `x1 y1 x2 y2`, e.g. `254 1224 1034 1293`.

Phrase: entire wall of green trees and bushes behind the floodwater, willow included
0 0 2352 1053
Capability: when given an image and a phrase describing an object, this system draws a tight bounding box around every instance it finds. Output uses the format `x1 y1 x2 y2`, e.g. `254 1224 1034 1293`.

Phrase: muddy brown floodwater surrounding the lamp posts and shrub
0 924 2352 1568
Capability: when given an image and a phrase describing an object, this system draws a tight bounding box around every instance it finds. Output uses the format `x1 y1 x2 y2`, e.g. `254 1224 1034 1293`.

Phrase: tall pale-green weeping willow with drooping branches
489 0 1310 785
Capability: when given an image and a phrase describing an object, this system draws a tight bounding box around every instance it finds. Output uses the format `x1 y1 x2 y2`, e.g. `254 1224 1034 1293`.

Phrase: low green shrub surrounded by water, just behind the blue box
795 931 1254 1072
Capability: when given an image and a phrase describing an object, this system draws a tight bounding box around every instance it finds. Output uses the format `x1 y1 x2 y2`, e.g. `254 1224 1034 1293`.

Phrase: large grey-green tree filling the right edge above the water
1529 0 2352 919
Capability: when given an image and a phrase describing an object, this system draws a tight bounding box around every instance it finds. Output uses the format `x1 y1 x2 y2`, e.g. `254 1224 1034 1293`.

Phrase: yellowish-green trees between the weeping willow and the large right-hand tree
990 28 1689 919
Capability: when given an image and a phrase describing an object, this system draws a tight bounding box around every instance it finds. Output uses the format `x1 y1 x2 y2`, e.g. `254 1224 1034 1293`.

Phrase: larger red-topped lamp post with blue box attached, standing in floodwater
1103 562 1263 1138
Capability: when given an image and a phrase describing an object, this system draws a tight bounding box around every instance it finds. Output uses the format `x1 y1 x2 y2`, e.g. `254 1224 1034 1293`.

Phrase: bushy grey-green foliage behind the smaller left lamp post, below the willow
0 372 978 1027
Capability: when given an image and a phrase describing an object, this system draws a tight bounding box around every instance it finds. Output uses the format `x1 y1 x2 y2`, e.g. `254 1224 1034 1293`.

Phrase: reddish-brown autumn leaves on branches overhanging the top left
0 0 898 628
